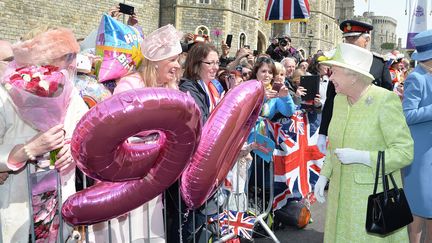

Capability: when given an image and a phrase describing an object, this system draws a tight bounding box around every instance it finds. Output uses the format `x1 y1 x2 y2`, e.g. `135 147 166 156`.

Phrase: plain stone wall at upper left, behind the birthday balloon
0 0 160 42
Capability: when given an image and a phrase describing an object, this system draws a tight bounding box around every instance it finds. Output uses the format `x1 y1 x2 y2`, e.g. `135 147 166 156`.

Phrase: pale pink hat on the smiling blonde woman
141 24 182 61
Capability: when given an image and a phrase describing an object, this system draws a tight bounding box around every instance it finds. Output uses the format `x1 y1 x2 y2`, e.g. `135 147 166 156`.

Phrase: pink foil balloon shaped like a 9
62 88 201 225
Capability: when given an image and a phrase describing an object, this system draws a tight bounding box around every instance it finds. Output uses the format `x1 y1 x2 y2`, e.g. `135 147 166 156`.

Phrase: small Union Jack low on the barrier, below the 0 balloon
209 210 256 240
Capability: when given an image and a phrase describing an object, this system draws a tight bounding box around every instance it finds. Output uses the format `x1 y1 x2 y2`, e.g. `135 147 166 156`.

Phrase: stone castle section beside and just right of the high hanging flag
273 0 342 58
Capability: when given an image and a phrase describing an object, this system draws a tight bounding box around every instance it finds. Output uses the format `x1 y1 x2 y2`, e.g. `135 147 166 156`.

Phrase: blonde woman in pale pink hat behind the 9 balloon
91 25 182 242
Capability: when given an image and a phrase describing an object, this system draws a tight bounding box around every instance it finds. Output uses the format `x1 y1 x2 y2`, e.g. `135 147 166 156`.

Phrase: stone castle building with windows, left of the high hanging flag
161 0 271 55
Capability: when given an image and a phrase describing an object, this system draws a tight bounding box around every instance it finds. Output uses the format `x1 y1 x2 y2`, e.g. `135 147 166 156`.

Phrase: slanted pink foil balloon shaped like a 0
181 80 264 209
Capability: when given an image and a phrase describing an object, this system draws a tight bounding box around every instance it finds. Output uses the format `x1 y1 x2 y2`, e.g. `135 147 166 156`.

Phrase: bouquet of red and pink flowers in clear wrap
3 63 73 168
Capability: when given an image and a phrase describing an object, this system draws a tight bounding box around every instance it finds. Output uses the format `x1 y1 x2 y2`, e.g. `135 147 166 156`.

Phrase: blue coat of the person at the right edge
402 65 432 218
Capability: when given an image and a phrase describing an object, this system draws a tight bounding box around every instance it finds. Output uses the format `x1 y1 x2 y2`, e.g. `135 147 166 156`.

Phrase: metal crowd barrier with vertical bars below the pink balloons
11 152 279 243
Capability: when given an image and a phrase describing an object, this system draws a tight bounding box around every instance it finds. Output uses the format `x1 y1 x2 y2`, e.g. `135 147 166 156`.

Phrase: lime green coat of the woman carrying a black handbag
321 85 414 243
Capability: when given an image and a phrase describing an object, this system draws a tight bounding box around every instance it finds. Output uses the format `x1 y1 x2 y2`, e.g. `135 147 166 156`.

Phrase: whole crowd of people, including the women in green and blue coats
0 4 432 243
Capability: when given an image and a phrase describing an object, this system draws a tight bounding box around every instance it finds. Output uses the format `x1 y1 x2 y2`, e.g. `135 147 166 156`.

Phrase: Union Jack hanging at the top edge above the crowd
264 0 310 23
